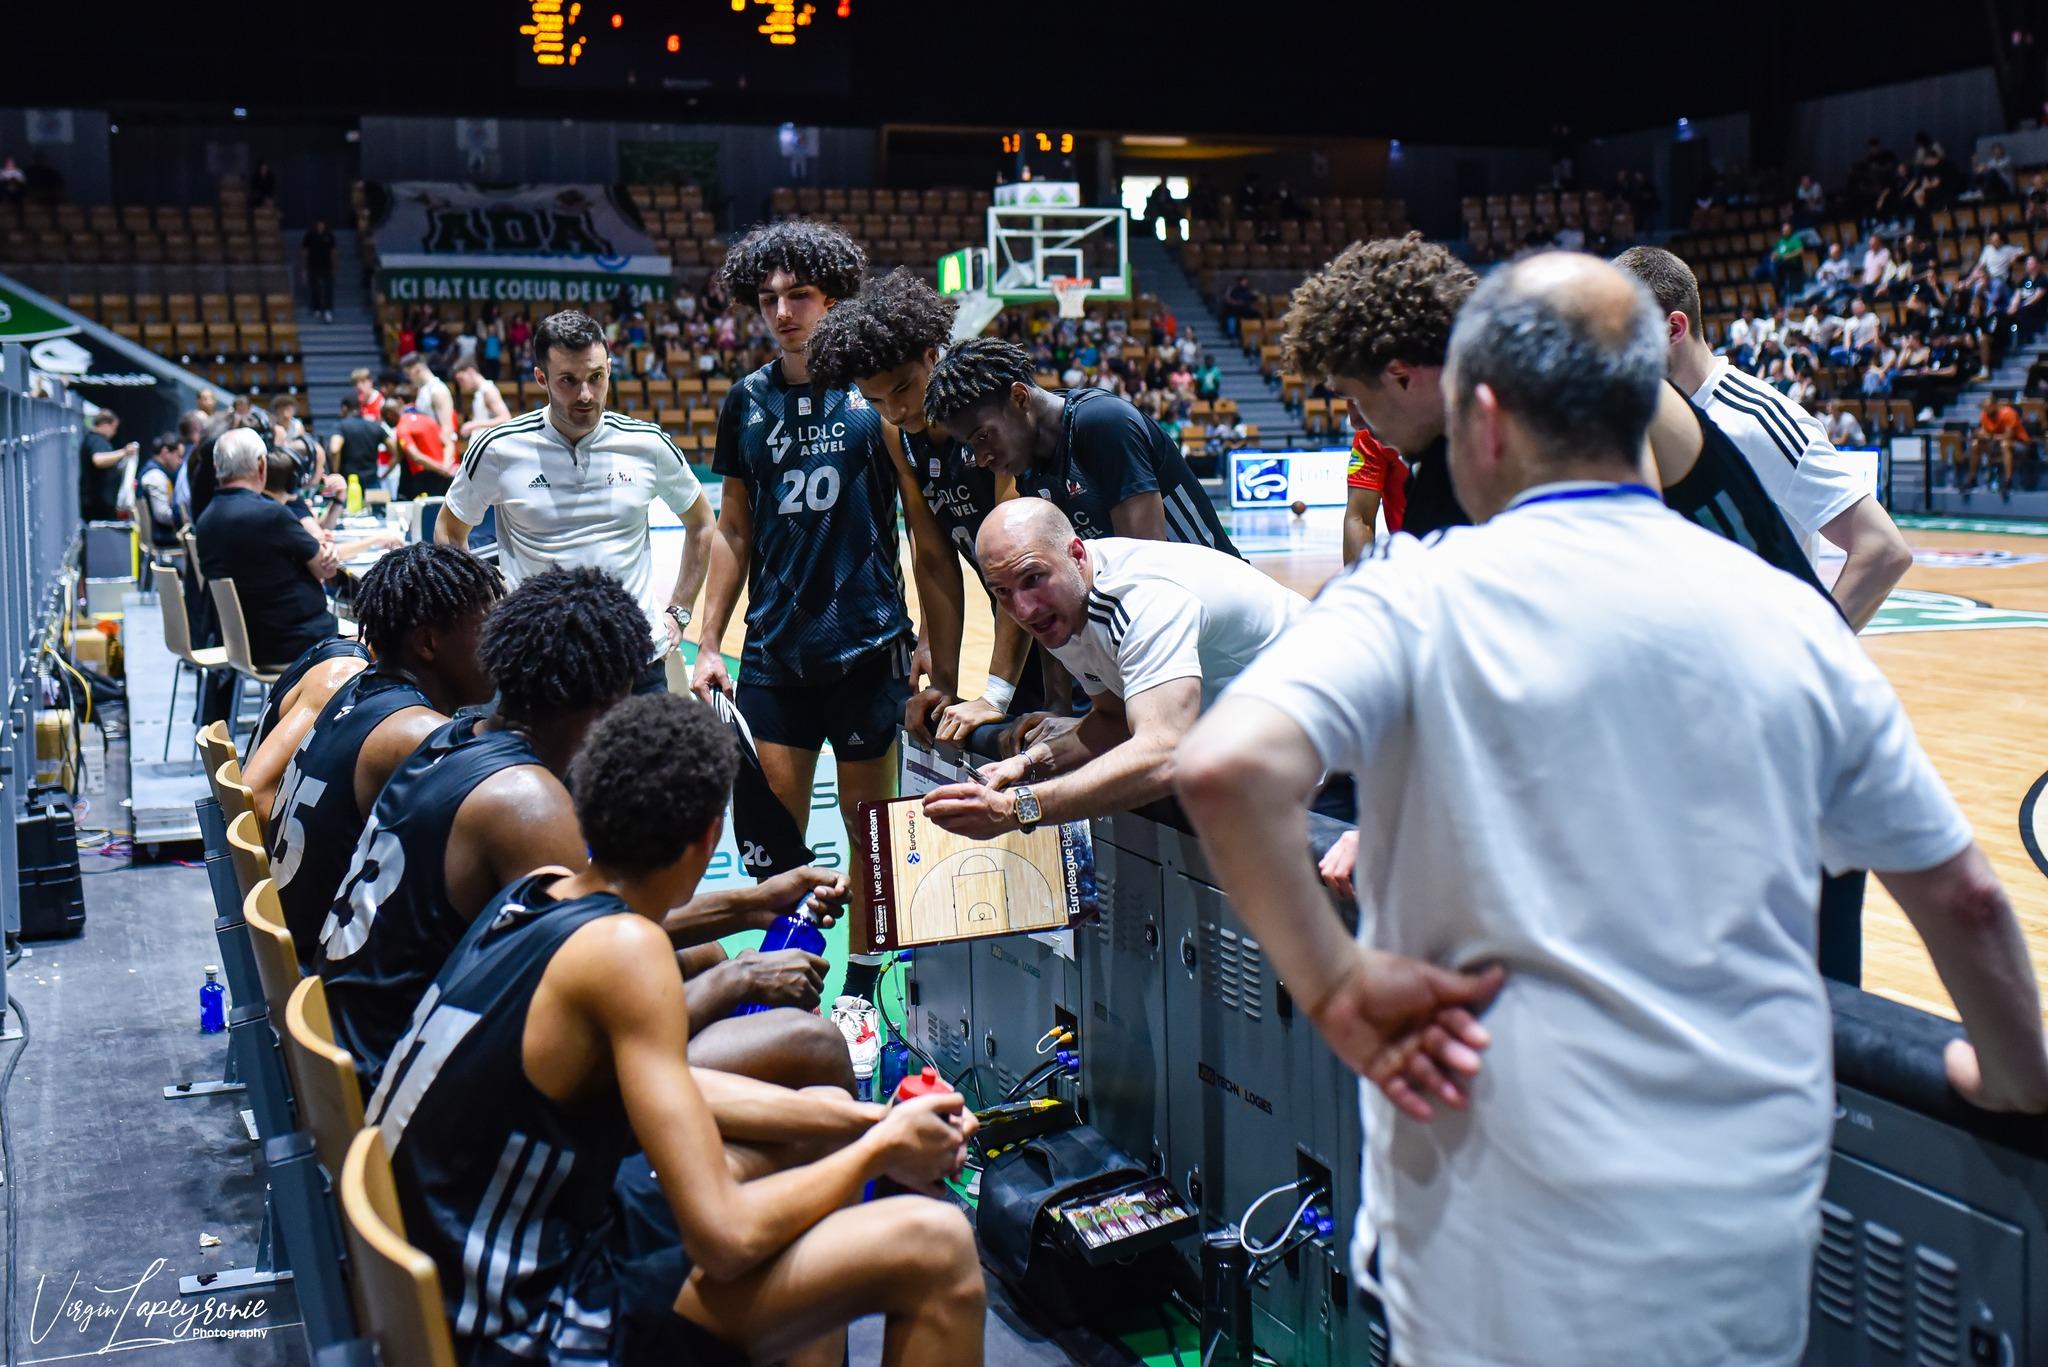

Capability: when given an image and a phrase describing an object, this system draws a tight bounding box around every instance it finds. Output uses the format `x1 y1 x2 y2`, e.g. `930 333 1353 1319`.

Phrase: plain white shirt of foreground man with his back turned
1233 486 1970 1367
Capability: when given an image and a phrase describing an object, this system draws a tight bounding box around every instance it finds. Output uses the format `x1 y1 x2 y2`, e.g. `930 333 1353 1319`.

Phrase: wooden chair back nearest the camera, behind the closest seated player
342 1129 455 1367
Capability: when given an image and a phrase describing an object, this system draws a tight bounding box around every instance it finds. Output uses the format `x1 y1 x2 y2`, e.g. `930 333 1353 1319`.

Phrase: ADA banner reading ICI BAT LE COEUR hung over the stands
373 180 672 303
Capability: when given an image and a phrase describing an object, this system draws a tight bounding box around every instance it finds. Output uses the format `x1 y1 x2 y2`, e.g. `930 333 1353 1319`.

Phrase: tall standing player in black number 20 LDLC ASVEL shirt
692 221 961 1024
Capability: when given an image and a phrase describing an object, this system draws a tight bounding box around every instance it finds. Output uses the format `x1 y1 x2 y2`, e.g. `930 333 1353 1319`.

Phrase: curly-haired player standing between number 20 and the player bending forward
807 266 1040 742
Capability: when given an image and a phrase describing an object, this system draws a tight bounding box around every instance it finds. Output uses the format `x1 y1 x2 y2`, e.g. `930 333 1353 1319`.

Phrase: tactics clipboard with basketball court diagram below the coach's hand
848 797 1094 953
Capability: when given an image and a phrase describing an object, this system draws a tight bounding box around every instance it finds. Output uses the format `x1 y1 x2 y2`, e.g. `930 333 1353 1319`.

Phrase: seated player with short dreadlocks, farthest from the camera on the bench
244 545 504 967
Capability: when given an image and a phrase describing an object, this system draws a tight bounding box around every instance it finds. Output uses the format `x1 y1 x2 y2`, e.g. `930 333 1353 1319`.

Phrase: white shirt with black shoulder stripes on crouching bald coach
1053 537 1309 711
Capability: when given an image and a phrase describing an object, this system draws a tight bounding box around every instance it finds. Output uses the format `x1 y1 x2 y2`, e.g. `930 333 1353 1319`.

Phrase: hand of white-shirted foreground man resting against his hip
1309 947 1507 1121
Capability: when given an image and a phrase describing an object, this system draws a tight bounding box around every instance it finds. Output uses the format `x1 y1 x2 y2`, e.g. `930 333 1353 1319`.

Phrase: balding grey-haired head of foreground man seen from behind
1444 252 1665 523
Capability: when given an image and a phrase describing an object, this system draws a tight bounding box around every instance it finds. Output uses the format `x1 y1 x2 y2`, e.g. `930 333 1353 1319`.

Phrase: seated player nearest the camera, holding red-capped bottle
380 695 985 1367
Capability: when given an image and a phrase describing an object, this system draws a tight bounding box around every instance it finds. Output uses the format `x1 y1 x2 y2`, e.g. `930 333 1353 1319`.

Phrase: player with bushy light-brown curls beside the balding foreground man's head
1280 234 1479 537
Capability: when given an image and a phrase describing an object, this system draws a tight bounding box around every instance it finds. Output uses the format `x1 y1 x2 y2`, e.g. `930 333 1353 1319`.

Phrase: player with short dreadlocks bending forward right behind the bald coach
924 336 1237 557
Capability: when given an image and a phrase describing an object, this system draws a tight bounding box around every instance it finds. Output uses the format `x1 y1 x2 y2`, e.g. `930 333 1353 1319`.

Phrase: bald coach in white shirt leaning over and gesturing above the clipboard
924 498 1309 838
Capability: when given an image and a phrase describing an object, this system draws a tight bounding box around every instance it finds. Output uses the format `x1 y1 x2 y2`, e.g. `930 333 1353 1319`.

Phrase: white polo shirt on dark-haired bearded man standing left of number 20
449 408 702 644
